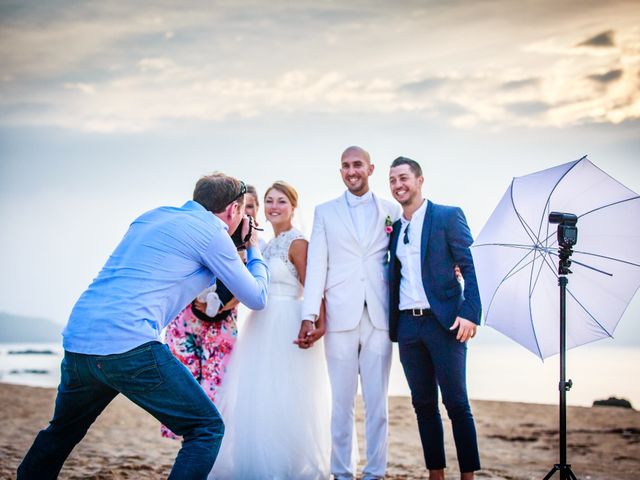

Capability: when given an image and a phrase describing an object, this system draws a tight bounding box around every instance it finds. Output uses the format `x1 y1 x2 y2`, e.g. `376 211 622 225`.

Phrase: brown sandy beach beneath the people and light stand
0 384 640 480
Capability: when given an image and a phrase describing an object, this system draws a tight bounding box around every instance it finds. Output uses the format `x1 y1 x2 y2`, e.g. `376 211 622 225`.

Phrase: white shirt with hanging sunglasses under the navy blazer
396 199 429 310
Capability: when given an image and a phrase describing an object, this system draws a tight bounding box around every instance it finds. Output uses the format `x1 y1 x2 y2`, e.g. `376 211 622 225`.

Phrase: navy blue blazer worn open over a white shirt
389 202 482 342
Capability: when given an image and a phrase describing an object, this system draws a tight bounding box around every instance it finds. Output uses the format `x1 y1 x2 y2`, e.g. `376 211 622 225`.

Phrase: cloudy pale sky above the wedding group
0 0 640 352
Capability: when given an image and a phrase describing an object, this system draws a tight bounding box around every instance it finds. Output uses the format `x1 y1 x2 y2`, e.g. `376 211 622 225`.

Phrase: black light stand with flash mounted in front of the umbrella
543 212 578 480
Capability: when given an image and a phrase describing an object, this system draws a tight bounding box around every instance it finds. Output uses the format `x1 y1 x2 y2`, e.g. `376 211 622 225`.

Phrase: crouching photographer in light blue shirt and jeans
18 173 269 479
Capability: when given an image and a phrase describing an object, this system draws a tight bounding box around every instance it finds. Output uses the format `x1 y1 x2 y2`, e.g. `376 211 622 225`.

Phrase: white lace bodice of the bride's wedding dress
262 228 304 297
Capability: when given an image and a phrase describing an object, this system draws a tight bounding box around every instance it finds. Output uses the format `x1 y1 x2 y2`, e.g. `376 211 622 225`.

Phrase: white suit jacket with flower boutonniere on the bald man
302 194 400 332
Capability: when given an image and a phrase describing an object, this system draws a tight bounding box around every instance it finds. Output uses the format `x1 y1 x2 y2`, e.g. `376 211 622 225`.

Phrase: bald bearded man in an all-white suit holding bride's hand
299 147 400 480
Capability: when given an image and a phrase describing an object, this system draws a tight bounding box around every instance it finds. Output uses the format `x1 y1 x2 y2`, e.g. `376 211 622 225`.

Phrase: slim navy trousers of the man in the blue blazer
398 313 480 472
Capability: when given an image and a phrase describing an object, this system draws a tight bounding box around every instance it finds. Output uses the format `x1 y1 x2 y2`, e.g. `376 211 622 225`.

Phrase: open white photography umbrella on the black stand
471 157 640 359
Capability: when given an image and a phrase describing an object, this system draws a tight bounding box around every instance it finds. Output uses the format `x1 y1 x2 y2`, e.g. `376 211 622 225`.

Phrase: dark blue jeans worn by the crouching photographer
18 342 224 479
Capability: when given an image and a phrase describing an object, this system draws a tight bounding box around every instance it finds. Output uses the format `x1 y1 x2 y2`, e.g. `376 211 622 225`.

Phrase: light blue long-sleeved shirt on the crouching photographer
62 201 269 355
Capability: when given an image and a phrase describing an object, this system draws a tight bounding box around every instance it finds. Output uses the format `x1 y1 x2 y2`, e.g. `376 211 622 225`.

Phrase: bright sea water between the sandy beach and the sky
0 342 640 409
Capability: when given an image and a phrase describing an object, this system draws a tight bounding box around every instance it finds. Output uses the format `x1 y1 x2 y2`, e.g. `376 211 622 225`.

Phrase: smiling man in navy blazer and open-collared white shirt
389 157 481 480
